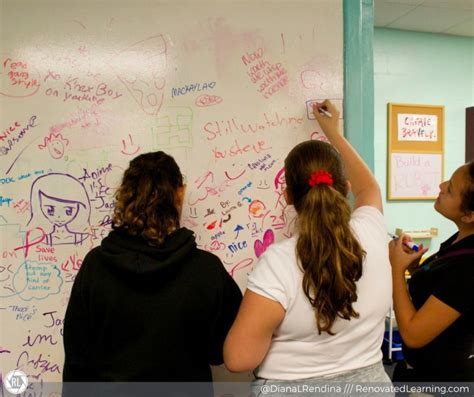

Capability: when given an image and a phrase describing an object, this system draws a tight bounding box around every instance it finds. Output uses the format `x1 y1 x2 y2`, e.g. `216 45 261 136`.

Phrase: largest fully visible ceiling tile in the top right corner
387 6 466 32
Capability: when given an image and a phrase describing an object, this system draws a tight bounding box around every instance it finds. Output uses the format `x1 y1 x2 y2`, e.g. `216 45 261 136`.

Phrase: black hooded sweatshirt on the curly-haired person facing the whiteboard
63 228 242 382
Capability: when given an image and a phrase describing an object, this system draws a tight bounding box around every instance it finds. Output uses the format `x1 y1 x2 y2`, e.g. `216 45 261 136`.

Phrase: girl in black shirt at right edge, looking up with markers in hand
390 161 474 382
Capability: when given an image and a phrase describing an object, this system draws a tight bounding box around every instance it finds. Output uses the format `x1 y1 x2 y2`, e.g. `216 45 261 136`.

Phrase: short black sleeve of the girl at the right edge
433 256 474 313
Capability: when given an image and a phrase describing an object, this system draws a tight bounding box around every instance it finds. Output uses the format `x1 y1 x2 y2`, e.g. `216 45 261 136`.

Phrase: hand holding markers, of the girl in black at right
389 233 428 273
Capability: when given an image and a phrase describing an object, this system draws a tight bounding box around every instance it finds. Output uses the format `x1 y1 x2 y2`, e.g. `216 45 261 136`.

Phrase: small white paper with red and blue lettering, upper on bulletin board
398 114 438 142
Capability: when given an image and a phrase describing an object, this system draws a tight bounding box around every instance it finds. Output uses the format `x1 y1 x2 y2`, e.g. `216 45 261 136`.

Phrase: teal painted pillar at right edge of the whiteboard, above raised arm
343 0 374 171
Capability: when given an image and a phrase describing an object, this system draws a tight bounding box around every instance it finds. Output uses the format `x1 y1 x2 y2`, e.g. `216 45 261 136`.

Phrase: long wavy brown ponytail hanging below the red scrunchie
296 185 364 335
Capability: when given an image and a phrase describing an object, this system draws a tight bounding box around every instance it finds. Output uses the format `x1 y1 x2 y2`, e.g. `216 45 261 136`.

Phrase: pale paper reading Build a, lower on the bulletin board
390 153 443 199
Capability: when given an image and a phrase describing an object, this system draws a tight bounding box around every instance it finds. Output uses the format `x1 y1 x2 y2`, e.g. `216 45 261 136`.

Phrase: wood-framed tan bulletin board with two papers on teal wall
387 103 444 200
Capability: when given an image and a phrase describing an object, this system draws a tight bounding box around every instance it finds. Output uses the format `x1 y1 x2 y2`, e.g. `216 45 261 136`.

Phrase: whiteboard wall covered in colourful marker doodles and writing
0 0 343 381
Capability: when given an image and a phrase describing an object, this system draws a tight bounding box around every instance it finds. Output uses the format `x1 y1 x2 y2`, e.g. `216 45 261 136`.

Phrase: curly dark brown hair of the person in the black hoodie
112 152 183 246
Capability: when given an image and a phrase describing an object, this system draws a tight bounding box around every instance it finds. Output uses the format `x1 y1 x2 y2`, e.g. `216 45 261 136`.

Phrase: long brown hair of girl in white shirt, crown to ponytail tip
285 141 365 335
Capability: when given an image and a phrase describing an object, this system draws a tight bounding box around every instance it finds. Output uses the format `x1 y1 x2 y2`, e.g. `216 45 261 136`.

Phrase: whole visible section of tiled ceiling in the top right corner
374 0 474 37
